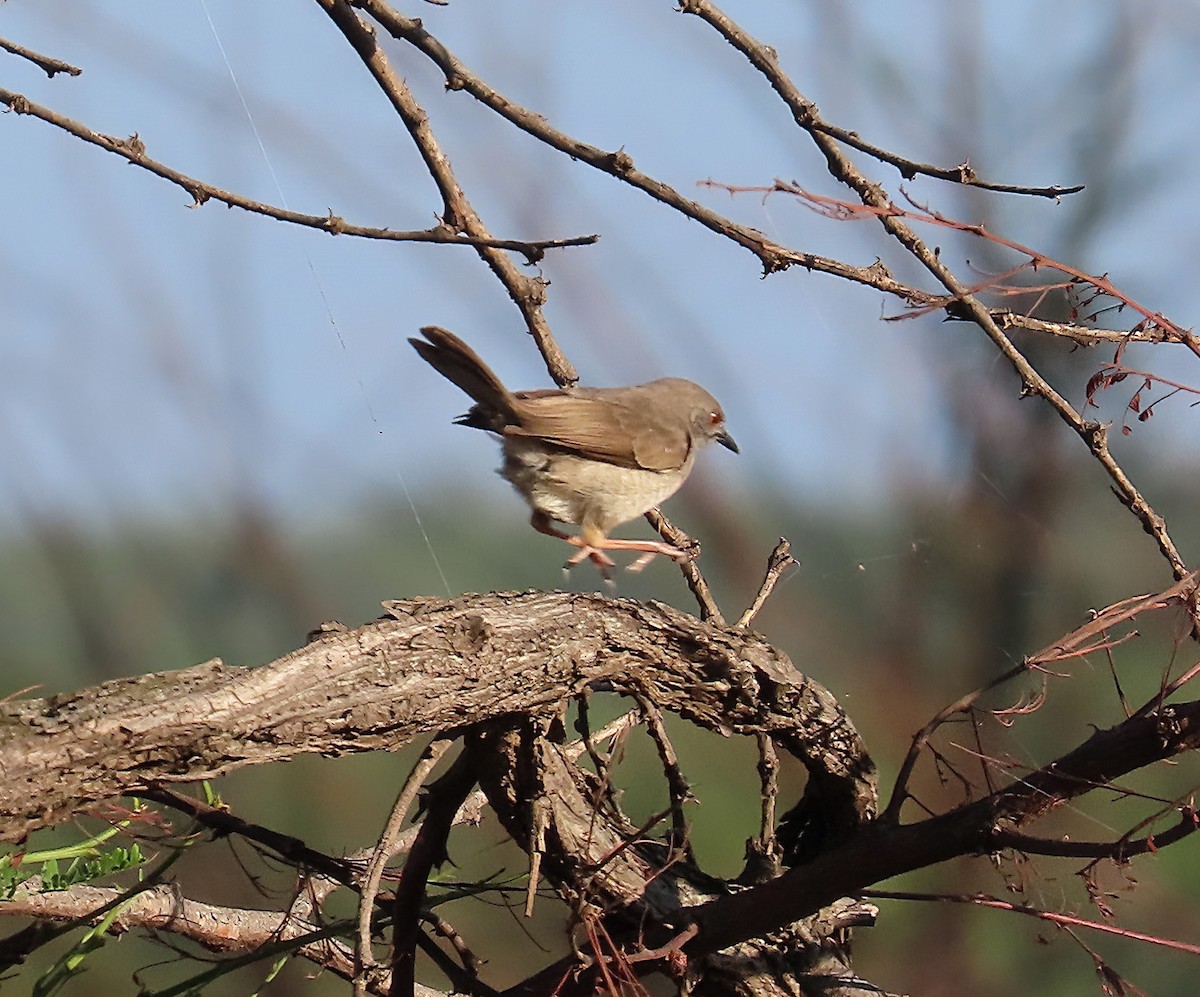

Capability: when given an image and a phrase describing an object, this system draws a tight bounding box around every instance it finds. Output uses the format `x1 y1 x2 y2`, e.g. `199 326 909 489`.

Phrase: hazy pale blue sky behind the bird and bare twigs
0 0 1200 547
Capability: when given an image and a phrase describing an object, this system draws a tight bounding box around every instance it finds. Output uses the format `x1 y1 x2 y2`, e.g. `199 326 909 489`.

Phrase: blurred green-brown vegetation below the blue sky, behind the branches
9 468 1200 997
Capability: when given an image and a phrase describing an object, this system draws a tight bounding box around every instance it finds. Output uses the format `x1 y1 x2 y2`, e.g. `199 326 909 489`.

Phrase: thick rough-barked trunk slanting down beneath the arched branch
470 720 878 997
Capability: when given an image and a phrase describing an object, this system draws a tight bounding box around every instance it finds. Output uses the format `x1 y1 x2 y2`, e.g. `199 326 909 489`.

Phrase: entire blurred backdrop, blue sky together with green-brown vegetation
0 0 1200 997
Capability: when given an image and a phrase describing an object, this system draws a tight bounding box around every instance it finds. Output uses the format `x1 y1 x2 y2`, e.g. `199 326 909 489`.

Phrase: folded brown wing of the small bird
504 389 691 470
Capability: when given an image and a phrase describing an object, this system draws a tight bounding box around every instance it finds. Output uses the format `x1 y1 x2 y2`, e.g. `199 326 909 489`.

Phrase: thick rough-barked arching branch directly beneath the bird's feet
0 593 875 840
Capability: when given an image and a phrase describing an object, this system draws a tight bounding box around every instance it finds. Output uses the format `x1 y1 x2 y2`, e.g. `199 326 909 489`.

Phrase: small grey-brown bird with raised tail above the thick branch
409 325 738 578
